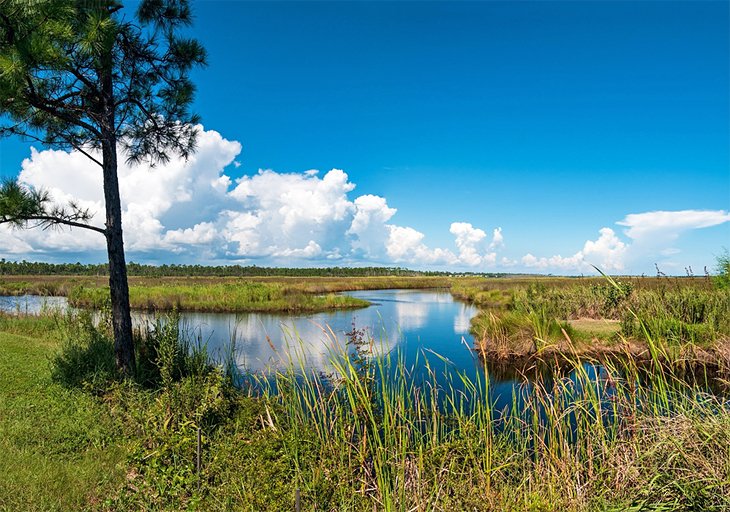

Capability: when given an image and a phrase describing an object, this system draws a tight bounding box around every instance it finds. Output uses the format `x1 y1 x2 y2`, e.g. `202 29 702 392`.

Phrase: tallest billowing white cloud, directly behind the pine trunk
3 127 241 253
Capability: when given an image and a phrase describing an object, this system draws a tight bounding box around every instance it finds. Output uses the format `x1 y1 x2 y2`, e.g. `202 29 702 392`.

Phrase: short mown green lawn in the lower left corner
0 332 126 511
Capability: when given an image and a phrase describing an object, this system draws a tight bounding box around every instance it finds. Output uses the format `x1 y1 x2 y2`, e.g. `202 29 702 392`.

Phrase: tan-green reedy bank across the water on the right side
453 278 730 371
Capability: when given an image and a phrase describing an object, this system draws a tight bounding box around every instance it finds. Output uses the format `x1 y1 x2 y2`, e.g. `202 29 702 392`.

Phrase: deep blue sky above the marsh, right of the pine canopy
0 1 730 274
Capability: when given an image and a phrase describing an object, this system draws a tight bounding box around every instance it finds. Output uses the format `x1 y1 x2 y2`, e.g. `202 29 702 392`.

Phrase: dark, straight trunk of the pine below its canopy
102 133 136 375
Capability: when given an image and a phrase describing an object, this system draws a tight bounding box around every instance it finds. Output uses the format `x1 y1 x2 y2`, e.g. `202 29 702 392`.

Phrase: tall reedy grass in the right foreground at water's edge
229 324 730 510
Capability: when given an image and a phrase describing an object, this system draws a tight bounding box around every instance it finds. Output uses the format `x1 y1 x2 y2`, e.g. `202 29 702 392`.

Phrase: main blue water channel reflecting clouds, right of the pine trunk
135 290 478 372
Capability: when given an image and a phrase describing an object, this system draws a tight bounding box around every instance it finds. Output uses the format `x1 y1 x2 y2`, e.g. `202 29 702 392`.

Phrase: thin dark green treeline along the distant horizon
0 259 508 277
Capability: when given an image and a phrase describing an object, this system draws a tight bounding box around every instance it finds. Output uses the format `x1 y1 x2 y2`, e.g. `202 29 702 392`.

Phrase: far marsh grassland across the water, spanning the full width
0 276 730 371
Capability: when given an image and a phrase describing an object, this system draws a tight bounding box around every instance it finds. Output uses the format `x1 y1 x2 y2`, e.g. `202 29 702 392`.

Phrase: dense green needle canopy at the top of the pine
0 0 205 165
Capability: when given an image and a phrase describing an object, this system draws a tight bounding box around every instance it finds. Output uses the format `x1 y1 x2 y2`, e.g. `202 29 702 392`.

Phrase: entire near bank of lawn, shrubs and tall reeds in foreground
0 310 730 511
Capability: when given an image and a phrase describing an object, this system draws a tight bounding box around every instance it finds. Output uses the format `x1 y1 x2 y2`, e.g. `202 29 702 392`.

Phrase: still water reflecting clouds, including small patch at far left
0 290 522 405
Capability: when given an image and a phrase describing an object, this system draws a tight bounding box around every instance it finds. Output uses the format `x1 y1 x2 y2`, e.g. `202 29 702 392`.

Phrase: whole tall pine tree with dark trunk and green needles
0 0 205 373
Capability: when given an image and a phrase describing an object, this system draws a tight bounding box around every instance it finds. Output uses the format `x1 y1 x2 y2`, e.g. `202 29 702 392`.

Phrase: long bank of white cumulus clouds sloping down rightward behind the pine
0 126 501 266
